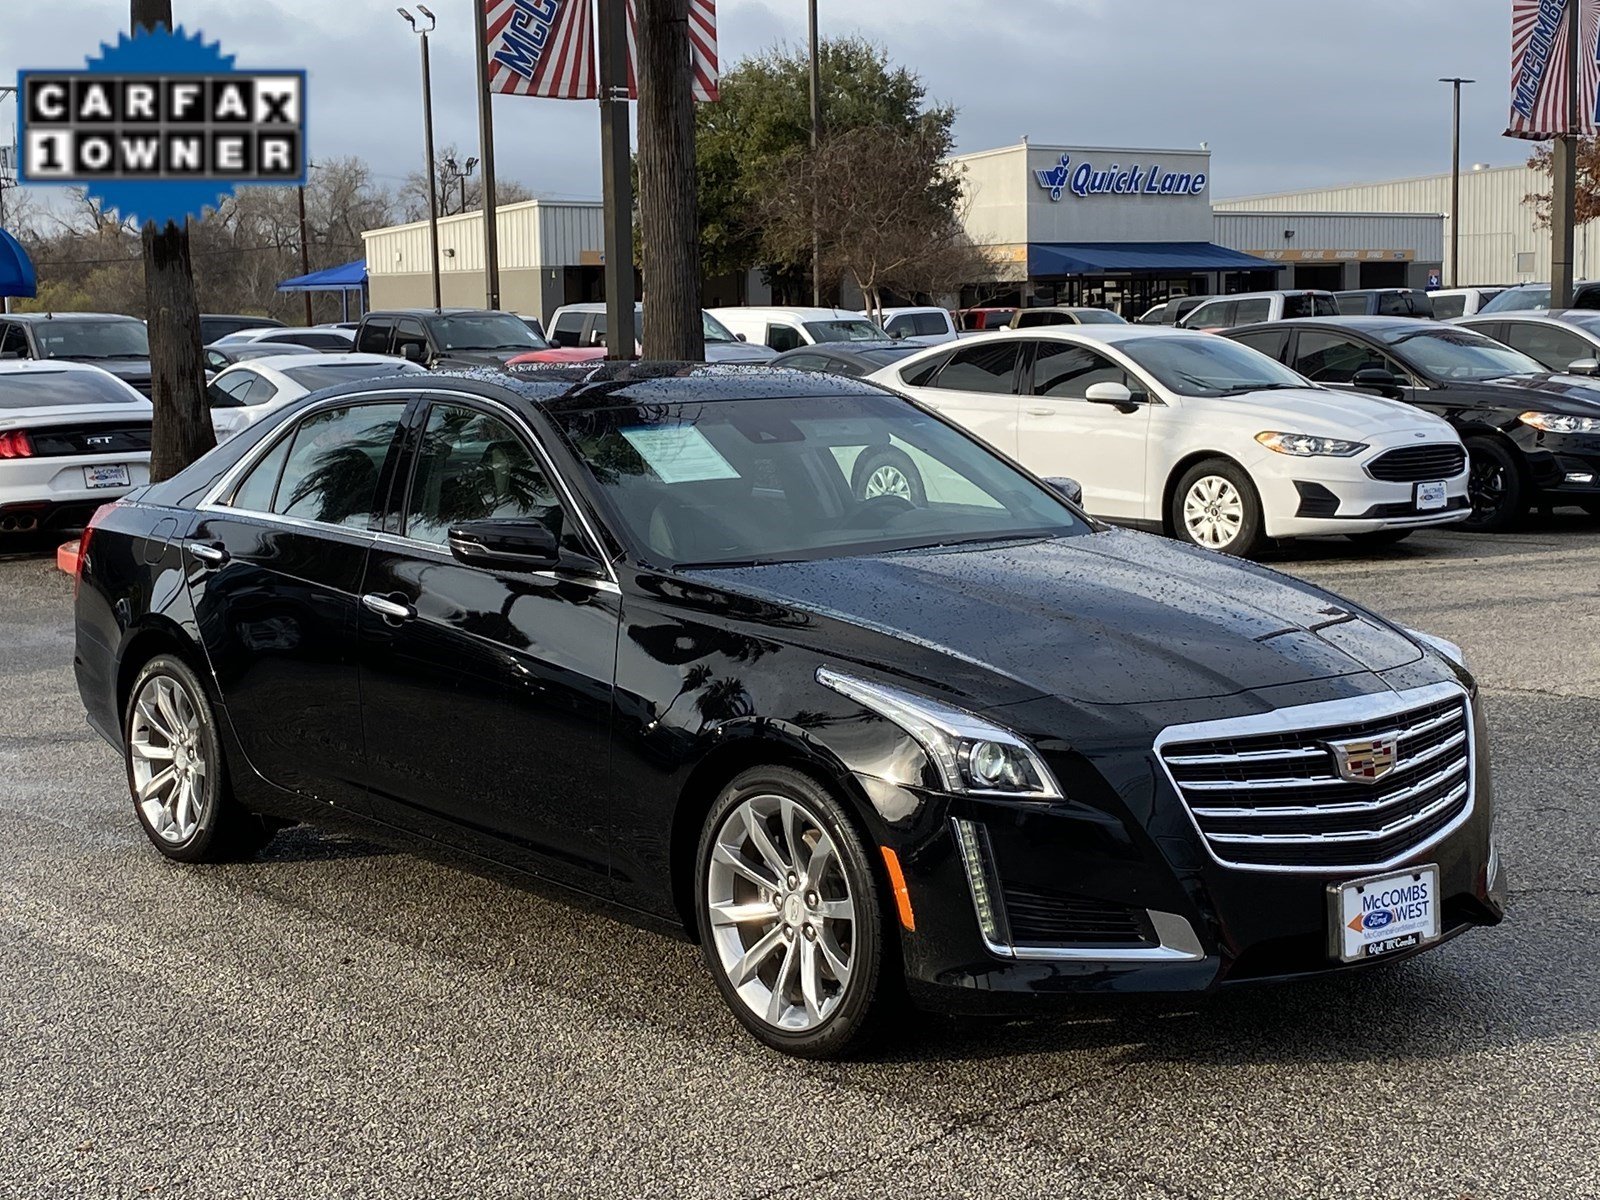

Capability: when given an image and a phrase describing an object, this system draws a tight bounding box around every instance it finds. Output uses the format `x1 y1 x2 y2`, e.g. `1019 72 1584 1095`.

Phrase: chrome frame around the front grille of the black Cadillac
1154 683 1478 878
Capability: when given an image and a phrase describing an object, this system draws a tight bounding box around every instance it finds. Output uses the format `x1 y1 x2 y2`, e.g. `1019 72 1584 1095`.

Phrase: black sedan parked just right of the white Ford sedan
1222 317 1600 530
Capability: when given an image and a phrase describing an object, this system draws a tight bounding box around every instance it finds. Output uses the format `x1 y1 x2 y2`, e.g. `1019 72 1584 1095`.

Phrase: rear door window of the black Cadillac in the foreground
234 400 405 530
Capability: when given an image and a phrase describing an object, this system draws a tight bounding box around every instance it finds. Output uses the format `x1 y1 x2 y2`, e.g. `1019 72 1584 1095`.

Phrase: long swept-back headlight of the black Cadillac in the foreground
816 667 1061 800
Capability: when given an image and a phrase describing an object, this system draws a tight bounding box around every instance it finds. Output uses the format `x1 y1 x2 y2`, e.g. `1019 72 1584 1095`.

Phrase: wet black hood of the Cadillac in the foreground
694 530 1422 706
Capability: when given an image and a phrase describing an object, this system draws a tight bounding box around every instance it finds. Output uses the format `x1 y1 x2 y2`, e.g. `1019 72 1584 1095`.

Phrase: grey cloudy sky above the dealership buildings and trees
0 0 1528 211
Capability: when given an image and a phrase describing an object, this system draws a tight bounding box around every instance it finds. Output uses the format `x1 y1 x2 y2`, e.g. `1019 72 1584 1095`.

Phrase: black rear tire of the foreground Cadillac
122 654 274 862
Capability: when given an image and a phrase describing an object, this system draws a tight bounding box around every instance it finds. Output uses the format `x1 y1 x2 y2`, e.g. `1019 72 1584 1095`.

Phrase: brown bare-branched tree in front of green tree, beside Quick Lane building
762 125 995 324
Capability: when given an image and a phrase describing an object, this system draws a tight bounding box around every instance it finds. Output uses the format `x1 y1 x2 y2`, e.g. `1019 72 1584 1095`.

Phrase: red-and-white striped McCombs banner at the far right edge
1506 0 1600 141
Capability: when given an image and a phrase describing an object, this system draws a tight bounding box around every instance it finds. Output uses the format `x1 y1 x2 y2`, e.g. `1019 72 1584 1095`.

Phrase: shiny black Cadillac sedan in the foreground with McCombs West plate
75 365 1502 1056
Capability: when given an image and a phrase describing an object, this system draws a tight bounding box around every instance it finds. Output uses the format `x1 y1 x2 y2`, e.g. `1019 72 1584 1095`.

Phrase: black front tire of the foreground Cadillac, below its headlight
694 766 902 1059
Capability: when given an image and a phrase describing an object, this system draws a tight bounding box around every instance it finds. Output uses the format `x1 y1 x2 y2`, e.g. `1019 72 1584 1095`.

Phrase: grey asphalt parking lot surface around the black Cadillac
0 524 1600 1200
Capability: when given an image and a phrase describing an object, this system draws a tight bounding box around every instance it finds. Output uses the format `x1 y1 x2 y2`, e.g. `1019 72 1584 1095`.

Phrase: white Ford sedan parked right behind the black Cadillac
853 325 1470 555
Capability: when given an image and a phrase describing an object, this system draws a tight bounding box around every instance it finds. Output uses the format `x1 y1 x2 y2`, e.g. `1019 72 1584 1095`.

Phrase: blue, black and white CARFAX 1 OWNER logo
18 29 306 227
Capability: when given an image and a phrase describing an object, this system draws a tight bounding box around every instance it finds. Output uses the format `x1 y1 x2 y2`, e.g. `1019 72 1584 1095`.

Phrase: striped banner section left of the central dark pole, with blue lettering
482 0 600 99
